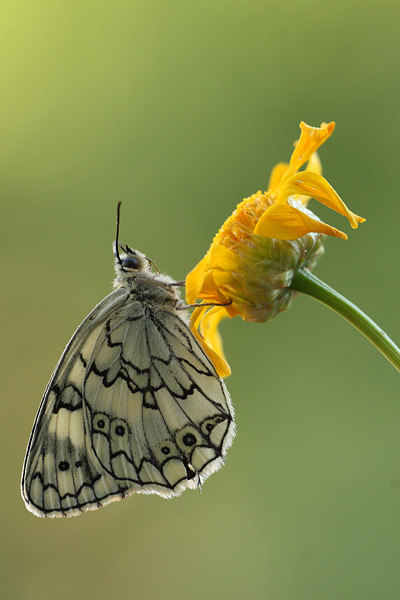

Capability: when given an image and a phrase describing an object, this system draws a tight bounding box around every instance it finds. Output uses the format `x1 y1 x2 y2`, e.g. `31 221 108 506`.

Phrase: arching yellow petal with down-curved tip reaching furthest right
280 171 365 229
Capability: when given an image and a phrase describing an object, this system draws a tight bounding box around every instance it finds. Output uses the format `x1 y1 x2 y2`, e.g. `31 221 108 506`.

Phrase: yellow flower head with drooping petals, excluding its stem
186 122 365 376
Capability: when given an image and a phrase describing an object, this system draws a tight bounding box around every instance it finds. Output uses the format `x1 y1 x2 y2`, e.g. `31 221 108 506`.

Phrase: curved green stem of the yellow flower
291 269 400 371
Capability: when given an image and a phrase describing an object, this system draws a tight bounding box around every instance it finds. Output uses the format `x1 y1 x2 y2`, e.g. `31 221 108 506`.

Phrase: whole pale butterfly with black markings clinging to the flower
21 205 235 517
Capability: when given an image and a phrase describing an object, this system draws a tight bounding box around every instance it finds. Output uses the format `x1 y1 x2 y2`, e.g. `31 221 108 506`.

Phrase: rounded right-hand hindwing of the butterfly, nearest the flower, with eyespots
84 301 234 497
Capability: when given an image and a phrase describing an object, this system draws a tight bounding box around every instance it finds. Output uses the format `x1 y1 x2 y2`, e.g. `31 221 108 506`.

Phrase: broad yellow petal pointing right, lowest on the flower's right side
254 204 347 240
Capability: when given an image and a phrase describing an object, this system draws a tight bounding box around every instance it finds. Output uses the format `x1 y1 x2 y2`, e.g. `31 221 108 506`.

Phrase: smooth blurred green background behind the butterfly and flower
0 0 400 600
